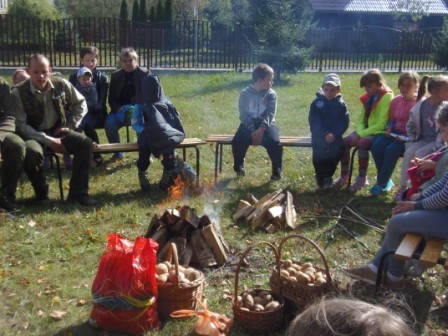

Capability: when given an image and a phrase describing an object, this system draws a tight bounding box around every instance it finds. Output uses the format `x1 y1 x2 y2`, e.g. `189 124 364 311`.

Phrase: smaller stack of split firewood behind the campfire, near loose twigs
233 189 297 233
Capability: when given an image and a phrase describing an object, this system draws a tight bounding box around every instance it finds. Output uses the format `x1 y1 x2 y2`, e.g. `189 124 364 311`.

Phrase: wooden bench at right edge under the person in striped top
376 233 448 287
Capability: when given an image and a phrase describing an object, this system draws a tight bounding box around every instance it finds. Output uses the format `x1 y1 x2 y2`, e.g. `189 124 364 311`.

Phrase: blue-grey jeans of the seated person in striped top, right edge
372 208 448 277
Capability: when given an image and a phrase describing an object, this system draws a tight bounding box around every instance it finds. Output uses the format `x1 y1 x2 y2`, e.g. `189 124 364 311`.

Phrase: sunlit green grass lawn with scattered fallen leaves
0 72 448 336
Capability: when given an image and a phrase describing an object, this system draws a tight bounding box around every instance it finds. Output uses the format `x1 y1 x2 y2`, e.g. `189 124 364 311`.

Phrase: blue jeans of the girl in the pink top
370 134 405 188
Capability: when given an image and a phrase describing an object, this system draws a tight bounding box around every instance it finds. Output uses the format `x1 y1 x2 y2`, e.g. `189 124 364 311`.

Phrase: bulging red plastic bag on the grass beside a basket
90 234 159 334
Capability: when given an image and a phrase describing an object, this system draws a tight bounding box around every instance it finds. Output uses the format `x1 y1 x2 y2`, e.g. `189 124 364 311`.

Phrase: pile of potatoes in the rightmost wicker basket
280 260 327 286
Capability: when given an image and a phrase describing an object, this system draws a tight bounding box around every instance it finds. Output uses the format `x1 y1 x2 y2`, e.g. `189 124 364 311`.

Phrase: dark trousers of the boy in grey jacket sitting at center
232 124 283 176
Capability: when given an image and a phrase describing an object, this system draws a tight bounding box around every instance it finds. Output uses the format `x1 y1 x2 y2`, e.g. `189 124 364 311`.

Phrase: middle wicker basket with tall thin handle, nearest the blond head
233 242 285 334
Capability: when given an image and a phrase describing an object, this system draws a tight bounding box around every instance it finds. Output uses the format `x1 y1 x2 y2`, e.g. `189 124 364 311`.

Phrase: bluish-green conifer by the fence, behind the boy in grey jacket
251 0 313 79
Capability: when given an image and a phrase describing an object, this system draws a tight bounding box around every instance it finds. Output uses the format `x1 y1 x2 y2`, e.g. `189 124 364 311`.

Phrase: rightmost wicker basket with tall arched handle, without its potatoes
269 234 336 307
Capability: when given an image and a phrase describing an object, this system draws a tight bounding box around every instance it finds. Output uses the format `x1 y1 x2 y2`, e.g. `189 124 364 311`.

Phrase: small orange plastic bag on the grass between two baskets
171 299 233 336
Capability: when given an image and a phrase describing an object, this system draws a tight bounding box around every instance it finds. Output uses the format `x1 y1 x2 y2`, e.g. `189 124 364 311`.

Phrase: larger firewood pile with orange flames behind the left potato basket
145 206 230 267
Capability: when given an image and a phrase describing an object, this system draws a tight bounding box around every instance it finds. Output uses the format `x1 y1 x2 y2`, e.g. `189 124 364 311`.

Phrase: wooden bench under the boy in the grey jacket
207 134 311 184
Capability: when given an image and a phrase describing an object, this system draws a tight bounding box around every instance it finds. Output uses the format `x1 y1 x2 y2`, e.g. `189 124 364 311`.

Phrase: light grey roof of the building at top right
310 0 448 15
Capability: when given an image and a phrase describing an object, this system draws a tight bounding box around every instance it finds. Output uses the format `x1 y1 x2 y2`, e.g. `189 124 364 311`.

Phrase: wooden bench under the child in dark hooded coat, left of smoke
93 138 206 188
